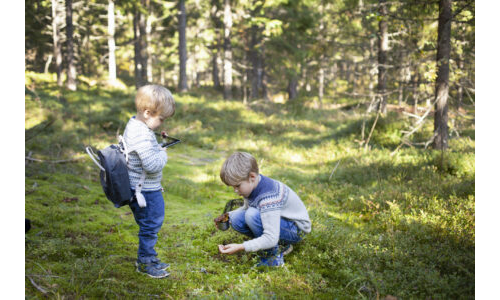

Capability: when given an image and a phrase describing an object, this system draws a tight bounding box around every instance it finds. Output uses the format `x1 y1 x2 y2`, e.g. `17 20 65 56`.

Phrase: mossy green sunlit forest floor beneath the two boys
25 73 475 299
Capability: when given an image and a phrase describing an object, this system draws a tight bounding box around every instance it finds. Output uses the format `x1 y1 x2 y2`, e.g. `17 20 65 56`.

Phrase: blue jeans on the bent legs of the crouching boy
231 207 302 249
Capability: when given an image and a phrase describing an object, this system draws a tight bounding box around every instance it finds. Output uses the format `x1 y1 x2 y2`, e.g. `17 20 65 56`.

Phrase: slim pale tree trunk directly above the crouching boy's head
224 0 233 99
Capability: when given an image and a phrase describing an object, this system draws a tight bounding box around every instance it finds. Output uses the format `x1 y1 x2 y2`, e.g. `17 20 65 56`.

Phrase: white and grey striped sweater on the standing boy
123 116 167 192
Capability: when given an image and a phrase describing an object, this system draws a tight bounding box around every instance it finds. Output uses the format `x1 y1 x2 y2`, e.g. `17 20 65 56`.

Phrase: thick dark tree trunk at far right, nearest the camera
434 0 452 150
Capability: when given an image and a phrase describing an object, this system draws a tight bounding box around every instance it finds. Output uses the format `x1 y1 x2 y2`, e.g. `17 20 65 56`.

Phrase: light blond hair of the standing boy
135 84 175 118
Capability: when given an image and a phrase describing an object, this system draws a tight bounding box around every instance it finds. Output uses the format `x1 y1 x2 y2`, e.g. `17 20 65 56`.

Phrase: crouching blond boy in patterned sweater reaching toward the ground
219 152 311 266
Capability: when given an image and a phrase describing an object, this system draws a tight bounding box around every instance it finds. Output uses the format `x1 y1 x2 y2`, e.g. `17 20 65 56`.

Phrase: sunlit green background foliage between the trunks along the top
25 0 475 111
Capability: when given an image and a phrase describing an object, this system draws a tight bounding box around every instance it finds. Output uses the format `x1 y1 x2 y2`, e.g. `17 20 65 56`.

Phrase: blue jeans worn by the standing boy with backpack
129 190 165 264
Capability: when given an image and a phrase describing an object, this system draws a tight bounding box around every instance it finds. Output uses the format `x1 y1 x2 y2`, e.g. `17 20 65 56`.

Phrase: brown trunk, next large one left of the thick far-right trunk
378 0 389 114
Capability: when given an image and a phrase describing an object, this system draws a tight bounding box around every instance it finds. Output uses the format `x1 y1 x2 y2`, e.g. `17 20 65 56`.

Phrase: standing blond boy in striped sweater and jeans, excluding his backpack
123 85 175 278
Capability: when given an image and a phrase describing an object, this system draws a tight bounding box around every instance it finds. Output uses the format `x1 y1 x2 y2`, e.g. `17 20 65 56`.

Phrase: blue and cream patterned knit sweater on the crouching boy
229 175 311 252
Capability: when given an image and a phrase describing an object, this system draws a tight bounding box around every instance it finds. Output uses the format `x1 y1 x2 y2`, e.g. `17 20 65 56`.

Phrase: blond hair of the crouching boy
220 152 259 186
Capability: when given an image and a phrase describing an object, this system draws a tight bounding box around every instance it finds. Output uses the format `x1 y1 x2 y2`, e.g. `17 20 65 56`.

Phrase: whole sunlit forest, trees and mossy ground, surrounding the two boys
25 0 476 300
